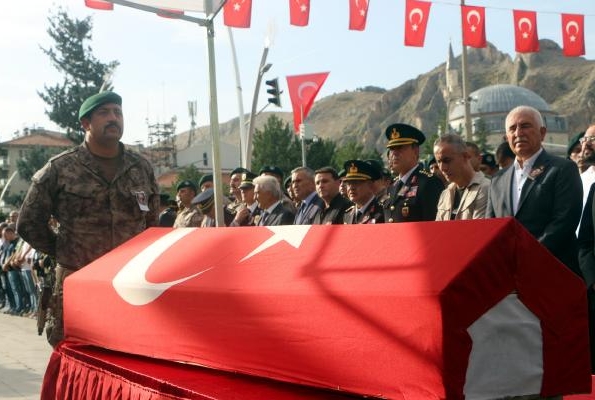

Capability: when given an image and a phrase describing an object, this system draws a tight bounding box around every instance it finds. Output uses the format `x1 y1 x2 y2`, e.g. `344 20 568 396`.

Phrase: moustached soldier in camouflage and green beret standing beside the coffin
17 92 159 346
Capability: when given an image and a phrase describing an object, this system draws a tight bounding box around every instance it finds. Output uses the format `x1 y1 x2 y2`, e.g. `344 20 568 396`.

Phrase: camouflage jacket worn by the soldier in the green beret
17 143 159 269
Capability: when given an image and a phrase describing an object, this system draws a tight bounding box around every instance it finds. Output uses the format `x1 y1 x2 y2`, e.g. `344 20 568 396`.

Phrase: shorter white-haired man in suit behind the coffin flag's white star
252 175 295 226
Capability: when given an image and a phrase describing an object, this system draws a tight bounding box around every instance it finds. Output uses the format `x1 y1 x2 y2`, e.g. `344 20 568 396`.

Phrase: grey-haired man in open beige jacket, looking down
434 134 490 221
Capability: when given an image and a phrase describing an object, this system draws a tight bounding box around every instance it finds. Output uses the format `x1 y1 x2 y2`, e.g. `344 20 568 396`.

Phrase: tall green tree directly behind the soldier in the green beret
38 7 119 143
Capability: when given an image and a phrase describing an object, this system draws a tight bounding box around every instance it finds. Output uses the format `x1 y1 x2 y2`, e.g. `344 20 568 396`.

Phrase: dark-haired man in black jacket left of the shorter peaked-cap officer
313 167 352 225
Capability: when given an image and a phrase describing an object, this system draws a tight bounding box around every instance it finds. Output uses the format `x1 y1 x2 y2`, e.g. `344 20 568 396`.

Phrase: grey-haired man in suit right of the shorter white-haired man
291 167 324 225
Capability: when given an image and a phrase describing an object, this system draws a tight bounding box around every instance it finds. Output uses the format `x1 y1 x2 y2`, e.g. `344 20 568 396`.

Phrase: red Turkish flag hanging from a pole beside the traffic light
287 72 329 133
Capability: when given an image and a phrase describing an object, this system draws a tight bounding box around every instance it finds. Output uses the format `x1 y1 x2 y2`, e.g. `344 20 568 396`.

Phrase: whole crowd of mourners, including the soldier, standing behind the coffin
0 92 595 396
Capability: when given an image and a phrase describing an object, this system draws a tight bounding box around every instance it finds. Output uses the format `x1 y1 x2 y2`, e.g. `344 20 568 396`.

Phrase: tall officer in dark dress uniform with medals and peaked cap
384 124 444 222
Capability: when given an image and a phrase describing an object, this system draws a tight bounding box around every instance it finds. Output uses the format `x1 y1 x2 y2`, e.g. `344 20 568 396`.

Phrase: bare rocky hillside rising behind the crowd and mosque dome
179 40 595 151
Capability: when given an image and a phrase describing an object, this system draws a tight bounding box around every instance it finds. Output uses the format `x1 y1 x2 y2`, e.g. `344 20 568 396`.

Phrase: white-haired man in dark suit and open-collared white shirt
487 106 583 276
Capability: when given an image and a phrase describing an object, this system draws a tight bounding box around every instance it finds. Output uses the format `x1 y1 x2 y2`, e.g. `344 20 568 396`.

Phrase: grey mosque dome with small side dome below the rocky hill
449 84 552 121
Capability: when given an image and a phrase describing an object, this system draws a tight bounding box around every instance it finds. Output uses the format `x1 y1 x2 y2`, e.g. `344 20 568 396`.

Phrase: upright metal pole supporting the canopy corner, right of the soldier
206 20 225 226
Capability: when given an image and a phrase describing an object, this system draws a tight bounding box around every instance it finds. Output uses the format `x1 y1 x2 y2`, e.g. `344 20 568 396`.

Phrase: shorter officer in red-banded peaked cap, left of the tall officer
343 160 384 224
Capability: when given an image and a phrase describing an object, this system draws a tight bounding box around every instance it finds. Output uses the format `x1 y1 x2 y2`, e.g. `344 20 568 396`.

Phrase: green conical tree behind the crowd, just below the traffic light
252 114 302 174
